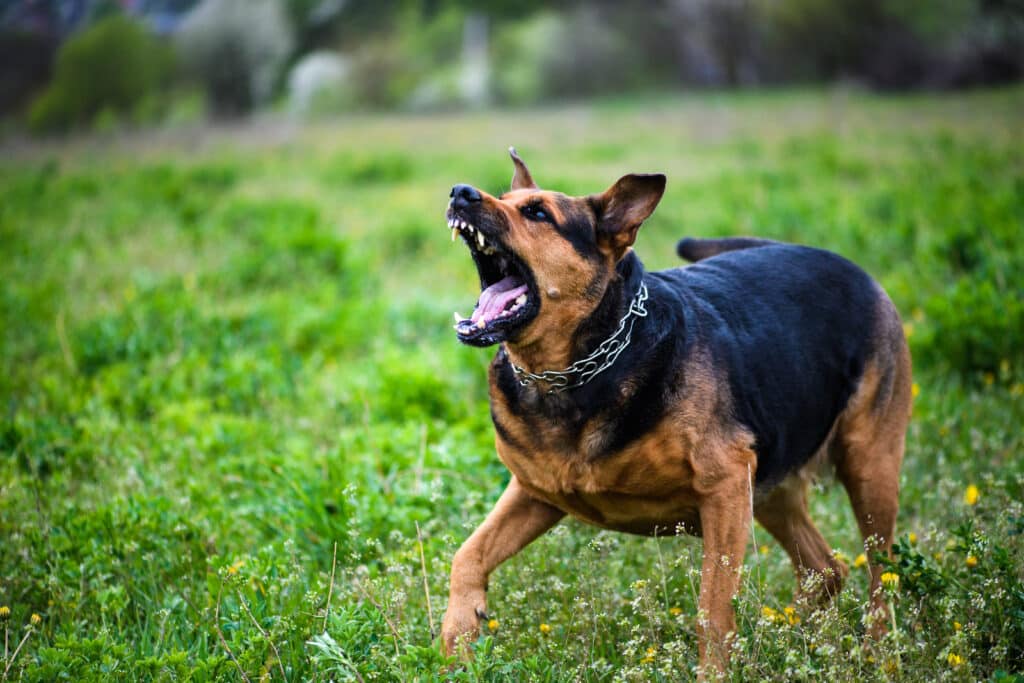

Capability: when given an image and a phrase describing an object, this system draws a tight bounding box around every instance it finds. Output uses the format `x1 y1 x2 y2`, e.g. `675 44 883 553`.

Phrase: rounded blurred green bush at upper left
29 15 174 132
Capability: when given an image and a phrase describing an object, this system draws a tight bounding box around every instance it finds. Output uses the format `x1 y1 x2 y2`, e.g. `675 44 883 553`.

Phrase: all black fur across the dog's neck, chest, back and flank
494 243 881 487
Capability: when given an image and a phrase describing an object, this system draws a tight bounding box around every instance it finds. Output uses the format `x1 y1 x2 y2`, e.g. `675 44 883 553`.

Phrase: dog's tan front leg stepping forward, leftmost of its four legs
441 476 565 657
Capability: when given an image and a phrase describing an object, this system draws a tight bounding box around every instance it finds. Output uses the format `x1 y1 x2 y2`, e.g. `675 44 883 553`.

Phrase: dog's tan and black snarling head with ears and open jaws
447 148 666 346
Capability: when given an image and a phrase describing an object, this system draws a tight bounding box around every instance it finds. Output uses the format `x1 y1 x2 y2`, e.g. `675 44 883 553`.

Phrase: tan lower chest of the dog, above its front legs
498 419 699 533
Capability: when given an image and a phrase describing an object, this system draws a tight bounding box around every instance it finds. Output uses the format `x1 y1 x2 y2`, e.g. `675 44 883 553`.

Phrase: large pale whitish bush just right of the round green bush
175 0 292 116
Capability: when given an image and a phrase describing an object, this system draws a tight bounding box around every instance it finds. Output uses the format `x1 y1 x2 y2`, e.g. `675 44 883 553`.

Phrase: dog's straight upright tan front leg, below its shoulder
697 469 751 678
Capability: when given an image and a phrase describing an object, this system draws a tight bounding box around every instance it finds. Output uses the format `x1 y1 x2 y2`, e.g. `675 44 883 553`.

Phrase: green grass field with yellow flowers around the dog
6 88 1024 681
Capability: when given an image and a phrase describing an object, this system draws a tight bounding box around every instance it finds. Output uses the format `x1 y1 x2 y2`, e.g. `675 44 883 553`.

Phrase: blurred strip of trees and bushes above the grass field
0 0 1024 134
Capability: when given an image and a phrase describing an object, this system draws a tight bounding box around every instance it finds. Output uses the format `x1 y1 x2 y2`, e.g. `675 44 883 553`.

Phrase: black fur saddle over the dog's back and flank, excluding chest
651 239 891 487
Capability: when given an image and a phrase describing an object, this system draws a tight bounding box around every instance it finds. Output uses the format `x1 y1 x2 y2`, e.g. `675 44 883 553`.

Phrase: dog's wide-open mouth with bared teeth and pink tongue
447 209 540 346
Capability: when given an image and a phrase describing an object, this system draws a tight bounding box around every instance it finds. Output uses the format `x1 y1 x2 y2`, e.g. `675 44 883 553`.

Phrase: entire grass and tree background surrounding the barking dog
0 0 1024 683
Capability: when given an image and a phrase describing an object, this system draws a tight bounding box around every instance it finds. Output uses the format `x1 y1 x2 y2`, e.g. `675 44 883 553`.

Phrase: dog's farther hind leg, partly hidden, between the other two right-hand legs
754 474 848 602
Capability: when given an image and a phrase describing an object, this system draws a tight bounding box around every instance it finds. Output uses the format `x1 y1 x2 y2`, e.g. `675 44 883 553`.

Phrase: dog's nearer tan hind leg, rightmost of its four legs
836 304 911 638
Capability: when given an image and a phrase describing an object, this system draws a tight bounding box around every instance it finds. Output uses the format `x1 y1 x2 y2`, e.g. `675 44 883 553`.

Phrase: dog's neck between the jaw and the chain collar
505 251 644 392
